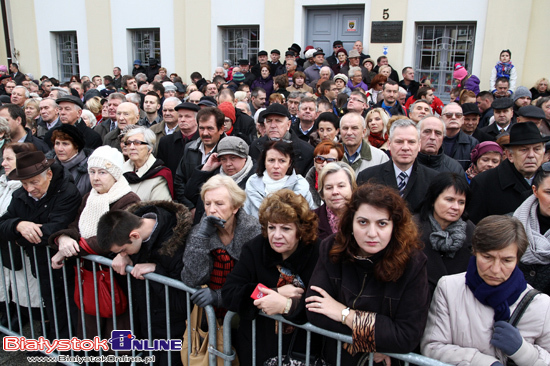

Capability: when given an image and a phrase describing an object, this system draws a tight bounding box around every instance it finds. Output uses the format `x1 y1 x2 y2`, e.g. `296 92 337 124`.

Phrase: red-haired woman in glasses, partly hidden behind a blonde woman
306 141 344 206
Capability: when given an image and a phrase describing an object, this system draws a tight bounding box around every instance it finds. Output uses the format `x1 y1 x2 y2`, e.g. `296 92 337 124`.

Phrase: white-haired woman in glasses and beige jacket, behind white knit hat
122 126 174 201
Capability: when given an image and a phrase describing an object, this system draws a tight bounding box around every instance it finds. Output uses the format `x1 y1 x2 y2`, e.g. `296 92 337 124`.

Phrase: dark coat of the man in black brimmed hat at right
466 160 532 224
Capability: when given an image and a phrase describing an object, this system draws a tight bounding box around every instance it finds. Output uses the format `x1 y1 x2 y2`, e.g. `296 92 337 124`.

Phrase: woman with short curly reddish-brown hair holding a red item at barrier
222 189 319 365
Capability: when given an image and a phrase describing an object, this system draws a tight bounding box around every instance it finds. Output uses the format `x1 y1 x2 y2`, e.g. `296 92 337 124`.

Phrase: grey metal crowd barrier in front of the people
0 243 449 366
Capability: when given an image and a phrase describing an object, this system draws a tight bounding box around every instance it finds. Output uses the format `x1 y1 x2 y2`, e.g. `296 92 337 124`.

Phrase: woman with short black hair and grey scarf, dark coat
415 172 475 294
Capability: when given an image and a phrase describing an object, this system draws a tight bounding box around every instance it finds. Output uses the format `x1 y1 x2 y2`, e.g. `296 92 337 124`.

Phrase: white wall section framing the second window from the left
111 0 176 75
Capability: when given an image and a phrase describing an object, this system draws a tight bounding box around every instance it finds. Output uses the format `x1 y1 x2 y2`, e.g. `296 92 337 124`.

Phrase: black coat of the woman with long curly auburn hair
306 236 430 365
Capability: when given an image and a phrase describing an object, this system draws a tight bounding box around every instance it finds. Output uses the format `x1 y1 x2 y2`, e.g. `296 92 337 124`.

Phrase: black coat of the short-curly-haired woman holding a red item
222 235 319 365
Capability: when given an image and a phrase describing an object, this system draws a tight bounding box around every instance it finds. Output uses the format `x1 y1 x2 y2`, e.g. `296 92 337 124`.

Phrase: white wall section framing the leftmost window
34 0 93 78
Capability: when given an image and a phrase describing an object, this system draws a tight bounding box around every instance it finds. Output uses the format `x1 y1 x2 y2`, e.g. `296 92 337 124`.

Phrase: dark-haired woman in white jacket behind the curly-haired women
244 139 317 217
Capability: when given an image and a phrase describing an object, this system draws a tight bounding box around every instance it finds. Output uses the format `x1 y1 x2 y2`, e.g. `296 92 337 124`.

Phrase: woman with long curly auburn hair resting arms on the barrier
306 183 430 365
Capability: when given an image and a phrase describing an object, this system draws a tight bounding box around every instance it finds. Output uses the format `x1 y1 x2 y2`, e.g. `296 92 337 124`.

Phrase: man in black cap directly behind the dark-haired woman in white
250 103 314 176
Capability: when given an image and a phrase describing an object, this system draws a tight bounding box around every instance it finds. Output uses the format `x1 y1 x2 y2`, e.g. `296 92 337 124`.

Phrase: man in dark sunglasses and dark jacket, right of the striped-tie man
441 103 479 170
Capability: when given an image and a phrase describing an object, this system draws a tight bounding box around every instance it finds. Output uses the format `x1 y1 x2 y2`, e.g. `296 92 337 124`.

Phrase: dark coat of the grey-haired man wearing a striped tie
357 160 439 212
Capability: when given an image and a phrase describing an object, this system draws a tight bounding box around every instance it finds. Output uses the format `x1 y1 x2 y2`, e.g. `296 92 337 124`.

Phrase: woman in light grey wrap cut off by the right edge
514 162 550 295
